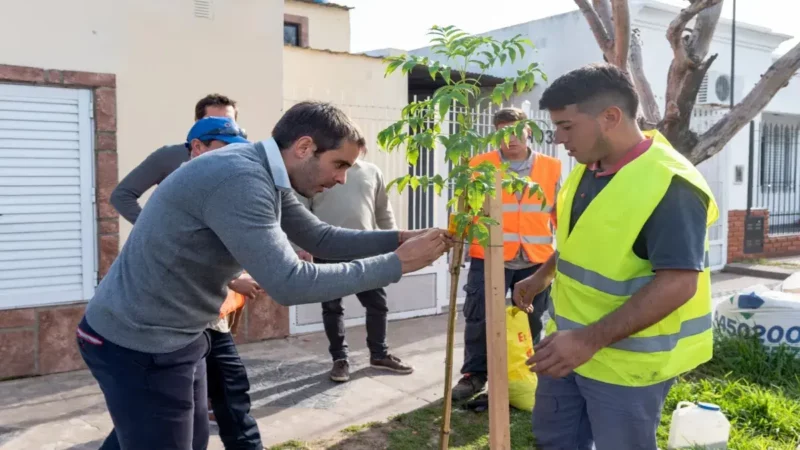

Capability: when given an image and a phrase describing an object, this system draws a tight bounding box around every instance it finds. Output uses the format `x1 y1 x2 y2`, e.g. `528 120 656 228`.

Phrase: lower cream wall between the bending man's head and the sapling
283 47 408 228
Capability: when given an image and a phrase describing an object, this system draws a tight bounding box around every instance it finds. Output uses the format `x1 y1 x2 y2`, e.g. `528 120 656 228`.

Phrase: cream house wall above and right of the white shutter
0 0 283 246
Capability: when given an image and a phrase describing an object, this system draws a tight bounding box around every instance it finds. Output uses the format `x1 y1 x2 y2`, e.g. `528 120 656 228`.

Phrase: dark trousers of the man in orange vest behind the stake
461 258 550 375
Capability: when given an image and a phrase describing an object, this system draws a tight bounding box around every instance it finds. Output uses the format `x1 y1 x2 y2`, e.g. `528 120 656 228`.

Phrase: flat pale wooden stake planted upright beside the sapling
484 170 511 450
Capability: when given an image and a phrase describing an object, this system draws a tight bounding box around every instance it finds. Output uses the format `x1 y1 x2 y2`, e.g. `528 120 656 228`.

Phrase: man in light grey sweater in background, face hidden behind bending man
298 159 414 382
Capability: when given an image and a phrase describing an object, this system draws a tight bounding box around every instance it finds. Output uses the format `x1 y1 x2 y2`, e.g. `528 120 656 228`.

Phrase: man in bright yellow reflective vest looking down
514 64 719 450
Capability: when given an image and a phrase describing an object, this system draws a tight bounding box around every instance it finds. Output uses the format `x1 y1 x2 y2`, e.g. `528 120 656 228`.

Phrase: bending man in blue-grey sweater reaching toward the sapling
77 102 451 450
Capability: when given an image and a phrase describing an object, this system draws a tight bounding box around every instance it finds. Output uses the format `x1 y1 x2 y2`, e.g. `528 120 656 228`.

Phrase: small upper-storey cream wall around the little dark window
284 0 350 52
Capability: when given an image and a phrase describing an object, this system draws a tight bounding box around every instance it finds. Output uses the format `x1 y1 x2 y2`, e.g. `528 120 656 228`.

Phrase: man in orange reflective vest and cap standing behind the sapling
452 108 561 401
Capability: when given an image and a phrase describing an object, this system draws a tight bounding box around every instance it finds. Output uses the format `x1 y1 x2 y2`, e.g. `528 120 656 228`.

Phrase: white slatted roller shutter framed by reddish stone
0 84 97 309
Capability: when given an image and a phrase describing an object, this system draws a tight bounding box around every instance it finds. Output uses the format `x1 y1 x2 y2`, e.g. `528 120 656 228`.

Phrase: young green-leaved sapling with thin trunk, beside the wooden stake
378 26 547 449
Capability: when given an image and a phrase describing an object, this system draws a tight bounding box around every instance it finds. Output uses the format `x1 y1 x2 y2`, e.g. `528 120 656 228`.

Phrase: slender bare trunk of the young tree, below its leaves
439 197 464 450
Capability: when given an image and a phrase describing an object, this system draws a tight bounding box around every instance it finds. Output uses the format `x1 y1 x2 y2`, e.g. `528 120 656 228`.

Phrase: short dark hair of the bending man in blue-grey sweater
272 101 367 153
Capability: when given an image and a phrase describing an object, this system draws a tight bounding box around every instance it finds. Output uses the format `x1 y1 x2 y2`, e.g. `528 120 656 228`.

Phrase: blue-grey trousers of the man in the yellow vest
533 372 675 450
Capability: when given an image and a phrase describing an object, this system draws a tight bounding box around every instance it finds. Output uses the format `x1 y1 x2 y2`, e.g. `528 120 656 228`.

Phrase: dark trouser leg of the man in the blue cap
206 330 263 450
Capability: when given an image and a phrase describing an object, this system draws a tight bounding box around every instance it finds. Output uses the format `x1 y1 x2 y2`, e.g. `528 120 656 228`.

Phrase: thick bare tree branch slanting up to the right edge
689 43 800 164
